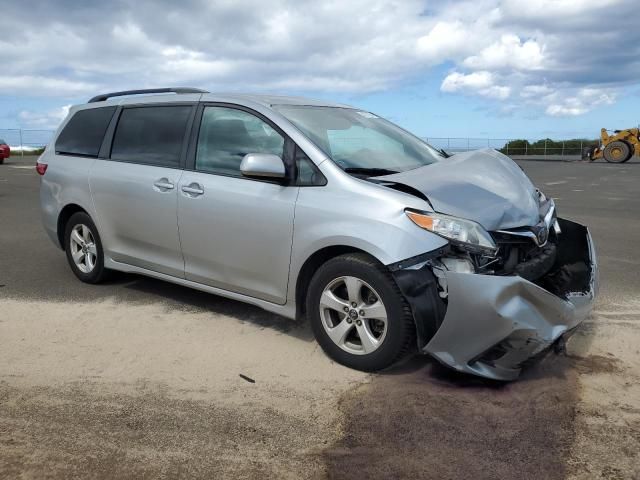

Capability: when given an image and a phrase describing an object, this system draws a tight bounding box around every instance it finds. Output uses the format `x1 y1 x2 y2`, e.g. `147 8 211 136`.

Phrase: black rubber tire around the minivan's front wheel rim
306 253 416 372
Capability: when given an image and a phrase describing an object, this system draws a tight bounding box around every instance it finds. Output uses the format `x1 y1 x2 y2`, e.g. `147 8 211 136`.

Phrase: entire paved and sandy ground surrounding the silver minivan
0 157 640 479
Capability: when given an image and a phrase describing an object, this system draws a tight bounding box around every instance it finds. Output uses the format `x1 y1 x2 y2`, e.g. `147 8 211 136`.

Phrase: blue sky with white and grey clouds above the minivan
0 0 640 139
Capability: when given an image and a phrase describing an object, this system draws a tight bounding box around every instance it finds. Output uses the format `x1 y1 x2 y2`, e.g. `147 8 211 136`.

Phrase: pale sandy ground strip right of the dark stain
568 297 640 479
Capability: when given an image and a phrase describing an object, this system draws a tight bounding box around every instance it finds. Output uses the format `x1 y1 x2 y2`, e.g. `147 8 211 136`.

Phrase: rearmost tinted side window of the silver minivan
56 107 116 157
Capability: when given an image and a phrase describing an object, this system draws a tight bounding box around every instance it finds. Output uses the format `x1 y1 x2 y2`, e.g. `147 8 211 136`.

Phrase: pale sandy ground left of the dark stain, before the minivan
0 299 367 478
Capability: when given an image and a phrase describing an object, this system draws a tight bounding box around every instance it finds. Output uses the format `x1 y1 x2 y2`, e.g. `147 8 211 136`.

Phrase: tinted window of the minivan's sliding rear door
111 105 192 167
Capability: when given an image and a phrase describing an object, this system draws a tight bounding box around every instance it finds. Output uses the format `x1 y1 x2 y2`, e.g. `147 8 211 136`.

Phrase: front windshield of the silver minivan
273 105 445 176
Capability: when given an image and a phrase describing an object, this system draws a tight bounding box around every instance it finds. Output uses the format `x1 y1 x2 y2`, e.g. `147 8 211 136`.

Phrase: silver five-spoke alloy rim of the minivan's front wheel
320 276 388 355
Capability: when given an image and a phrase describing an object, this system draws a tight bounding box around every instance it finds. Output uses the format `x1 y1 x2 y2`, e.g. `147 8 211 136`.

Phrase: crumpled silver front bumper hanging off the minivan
423 220 598 380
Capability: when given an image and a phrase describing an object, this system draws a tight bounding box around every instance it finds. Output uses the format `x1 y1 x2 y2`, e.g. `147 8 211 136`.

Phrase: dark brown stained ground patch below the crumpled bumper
324 355 578 479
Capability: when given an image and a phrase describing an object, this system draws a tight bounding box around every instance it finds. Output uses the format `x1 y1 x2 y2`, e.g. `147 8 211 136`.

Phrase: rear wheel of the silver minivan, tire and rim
64 212 108 283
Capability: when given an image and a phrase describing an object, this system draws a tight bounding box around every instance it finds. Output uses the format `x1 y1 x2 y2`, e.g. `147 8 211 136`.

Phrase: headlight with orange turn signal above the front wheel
405 209 496 252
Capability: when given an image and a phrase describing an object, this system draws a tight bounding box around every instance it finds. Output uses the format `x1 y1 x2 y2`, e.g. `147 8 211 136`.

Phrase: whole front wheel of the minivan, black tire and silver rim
306 254 415 372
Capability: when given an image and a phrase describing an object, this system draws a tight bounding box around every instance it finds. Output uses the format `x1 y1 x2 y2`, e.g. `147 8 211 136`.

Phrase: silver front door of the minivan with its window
178 106 298 304
